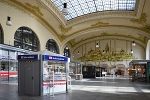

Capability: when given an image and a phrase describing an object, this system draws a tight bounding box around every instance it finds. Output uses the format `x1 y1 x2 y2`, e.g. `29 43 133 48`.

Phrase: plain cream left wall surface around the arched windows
0 2 59 50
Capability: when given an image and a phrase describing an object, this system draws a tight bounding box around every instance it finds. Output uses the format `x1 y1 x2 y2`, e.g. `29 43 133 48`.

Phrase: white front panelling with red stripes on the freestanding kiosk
43 61 66 95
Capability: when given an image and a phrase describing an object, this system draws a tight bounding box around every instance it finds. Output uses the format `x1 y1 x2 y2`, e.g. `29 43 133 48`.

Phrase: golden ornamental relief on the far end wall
78 48 138 62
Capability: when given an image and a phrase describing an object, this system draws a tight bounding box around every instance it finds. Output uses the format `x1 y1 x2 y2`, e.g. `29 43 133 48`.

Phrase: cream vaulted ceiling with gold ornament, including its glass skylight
4 0 150 47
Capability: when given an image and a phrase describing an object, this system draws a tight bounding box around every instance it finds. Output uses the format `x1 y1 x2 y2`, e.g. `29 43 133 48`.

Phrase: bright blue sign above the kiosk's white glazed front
44 55 68 62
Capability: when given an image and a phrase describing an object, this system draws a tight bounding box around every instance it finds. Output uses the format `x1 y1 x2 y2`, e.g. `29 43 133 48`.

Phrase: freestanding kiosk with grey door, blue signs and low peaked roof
18 50 70 96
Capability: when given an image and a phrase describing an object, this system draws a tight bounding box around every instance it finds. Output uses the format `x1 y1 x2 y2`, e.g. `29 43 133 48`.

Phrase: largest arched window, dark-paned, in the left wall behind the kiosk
14 27 39 51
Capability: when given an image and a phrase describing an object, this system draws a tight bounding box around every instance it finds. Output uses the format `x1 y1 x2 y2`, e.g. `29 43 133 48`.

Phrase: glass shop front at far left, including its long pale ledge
0 44 31 82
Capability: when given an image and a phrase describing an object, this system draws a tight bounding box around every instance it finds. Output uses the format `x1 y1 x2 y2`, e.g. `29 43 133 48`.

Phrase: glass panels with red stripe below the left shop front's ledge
0 49 18 82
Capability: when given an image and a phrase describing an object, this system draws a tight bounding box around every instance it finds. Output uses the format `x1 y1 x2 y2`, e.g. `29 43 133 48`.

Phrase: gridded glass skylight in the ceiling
51 0 136 20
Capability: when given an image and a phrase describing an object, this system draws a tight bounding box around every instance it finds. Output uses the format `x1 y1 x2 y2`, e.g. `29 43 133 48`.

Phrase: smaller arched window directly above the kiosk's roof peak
46 39 59 54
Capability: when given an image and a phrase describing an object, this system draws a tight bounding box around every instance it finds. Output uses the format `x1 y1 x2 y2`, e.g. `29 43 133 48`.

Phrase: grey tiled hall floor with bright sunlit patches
0 77 150 100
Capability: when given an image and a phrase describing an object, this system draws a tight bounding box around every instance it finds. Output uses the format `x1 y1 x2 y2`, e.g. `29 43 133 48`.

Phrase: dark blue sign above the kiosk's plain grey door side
18 55 39 60
